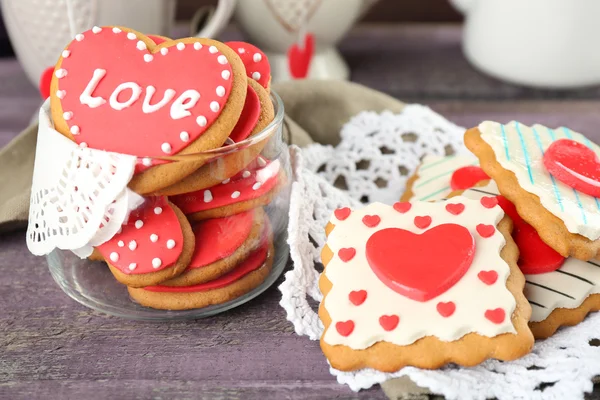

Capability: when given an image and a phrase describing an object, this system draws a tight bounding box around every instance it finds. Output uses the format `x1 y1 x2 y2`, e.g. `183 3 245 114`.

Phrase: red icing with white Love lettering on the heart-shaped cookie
53 27 233 157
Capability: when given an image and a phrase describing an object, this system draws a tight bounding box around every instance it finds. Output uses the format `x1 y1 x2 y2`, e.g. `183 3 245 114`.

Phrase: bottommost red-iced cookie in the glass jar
128 225 274 310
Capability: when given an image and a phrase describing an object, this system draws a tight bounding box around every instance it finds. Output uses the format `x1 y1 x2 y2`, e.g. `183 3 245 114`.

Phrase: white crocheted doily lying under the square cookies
279 105 600 400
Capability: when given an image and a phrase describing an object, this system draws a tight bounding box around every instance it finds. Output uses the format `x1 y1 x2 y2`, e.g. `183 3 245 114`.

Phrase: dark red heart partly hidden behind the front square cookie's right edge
497 196 565 274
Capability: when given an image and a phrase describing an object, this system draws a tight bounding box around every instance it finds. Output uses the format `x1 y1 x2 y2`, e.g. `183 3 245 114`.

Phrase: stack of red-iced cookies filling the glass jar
50 26 286 310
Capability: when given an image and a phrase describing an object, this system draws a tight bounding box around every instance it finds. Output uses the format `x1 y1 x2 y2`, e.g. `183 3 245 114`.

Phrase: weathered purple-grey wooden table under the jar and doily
0 25 600 399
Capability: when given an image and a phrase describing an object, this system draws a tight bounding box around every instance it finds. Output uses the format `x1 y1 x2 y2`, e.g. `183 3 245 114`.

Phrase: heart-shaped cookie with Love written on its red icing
50 26 248 194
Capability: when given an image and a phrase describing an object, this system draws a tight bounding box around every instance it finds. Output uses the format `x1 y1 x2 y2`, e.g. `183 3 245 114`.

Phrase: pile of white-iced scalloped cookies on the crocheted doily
319 122 600 372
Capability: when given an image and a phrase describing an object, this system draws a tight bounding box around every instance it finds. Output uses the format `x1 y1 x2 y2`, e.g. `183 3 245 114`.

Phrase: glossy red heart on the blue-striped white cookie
544 139 600 197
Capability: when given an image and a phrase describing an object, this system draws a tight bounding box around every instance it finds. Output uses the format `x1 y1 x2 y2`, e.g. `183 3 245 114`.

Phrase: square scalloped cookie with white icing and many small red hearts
319 197 533 372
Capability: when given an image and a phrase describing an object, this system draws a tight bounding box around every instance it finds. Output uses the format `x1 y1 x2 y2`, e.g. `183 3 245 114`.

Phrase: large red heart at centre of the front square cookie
366 224 475 301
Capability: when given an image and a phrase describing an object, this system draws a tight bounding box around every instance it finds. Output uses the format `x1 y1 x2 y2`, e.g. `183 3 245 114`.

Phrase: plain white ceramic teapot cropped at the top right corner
450 0 600 88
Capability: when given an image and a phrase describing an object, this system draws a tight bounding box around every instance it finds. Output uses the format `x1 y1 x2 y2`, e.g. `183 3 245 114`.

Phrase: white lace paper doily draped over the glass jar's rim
27 102 143 257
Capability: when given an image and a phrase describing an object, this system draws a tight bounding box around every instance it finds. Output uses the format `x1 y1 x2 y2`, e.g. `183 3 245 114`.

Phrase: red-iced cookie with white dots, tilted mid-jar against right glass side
169 156 285 221
